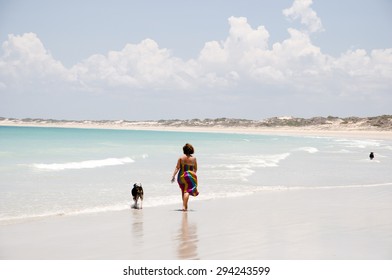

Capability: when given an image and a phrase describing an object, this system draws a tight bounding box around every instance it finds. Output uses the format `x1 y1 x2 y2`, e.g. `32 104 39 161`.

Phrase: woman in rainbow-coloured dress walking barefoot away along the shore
171 143 199 211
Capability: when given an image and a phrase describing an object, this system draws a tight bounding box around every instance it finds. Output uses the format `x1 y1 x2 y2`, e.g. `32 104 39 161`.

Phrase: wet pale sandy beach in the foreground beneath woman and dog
0 186 392 260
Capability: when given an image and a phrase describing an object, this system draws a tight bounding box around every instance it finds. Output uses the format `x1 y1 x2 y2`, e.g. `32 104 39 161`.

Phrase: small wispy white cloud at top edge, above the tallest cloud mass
283 0 323 32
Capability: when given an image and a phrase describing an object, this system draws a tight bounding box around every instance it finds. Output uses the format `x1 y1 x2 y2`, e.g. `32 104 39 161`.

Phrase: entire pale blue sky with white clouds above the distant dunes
0 0 392 120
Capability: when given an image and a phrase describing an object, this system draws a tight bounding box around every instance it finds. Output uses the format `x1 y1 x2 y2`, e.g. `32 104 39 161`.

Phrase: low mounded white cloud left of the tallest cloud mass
70 39 194 89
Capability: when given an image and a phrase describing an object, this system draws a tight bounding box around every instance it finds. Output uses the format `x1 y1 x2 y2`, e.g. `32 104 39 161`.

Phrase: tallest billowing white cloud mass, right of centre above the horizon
198 17 331 85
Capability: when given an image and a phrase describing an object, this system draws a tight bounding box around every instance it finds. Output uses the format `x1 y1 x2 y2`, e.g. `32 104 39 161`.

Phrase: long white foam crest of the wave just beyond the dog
32 157 135 171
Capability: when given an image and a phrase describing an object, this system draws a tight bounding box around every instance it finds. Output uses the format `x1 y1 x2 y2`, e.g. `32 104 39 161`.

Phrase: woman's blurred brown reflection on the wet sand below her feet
176 212 199 259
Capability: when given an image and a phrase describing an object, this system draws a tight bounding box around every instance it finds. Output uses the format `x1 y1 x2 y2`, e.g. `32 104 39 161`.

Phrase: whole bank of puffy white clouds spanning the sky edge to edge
0 0 392 118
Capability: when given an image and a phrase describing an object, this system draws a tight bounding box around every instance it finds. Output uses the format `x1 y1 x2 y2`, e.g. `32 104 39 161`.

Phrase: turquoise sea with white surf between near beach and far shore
0 127 392 224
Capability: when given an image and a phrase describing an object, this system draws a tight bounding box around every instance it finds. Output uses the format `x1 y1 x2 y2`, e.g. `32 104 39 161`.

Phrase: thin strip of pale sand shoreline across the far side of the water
0 120 392 139
